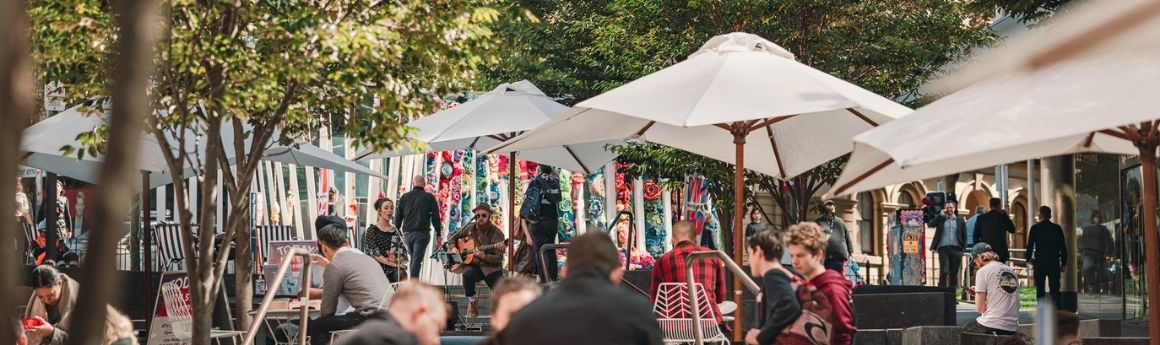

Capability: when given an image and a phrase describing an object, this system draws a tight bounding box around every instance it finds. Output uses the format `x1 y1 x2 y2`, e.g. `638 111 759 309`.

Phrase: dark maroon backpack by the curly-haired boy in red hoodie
760 269 833 345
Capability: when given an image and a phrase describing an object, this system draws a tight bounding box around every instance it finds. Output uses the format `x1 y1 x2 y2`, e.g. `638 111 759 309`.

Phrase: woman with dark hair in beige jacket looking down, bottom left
24 265 80 345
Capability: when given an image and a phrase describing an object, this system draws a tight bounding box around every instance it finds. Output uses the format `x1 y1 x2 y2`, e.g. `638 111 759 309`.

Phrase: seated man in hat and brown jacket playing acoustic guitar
448 203 503 317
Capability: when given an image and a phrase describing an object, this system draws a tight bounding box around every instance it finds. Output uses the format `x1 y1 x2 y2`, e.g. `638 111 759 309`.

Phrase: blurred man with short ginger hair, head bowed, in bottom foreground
335 279 448 345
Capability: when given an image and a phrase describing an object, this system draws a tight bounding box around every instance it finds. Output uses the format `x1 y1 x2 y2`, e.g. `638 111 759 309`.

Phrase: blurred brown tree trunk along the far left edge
0 1 36 344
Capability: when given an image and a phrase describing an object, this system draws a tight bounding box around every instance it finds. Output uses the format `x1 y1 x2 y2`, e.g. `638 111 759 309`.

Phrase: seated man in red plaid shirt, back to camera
650 221 725 324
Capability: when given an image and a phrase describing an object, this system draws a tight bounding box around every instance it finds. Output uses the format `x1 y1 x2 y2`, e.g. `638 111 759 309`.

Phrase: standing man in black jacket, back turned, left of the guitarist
394 175 443 278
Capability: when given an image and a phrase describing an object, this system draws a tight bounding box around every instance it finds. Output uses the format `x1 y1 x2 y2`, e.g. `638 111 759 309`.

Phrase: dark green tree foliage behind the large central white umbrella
486 0 993 228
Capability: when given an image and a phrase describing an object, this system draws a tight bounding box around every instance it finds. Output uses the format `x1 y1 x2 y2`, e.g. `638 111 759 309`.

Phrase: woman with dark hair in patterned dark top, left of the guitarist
364 197 407 282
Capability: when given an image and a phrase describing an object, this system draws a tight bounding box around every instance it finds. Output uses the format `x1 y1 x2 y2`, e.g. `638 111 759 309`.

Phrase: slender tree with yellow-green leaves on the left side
29 0 509 344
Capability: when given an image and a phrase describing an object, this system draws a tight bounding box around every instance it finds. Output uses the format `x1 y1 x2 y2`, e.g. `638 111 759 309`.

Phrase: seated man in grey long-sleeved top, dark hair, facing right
309 223 391 345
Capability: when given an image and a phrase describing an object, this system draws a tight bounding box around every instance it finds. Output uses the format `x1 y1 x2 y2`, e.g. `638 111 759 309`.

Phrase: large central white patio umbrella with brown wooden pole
496 33 911 336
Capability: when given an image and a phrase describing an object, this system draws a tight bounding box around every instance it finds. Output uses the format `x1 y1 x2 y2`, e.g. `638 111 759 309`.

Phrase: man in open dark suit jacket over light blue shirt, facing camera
927 200 966 290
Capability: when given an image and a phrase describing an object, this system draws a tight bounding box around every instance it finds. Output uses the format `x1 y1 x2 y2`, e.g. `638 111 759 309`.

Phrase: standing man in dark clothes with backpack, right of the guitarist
520 164 561 281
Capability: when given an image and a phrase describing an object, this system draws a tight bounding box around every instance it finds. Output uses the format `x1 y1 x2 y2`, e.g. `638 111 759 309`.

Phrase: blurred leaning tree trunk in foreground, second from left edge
68 1 157 345
